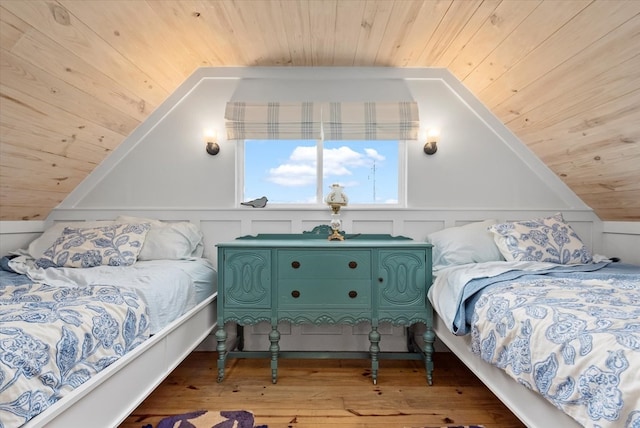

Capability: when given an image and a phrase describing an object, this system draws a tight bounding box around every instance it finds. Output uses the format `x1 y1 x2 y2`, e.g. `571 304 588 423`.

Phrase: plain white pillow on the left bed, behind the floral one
116 216 204 260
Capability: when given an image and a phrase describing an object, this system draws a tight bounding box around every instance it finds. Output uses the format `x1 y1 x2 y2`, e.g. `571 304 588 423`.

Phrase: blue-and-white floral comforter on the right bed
464 265 640 428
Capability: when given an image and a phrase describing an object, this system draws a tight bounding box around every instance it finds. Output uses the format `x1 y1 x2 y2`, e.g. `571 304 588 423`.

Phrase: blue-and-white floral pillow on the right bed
488 213 593 265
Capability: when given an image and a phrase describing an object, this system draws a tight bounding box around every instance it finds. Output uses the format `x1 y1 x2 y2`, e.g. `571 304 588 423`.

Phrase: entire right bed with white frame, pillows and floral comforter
428 214 640 428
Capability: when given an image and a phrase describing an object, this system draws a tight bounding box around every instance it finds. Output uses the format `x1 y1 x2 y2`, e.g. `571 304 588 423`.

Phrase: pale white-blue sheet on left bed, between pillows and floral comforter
9 256 216 334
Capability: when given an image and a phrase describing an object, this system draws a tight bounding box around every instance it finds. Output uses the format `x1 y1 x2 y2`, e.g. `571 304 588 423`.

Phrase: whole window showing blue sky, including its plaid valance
225 101 419 206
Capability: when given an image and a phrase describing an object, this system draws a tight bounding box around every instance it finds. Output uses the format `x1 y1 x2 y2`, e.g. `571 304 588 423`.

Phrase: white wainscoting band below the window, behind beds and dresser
42 206 603 264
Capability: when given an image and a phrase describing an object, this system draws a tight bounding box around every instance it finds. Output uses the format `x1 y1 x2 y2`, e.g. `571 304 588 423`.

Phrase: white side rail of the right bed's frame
434 316 582 428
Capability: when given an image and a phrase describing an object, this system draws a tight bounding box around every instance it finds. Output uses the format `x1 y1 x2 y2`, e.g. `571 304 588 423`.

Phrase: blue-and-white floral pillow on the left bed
36 223 150 268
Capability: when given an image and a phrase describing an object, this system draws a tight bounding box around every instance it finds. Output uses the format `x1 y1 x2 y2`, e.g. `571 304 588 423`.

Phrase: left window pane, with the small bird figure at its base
243 140 318 204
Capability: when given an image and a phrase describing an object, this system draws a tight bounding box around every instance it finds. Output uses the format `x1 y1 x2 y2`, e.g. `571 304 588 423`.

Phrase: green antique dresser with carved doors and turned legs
216 233 435 385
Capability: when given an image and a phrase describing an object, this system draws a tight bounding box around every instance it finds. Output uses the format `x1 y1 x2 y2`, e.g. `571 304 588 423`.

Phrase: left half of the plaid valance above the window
224 101 321 140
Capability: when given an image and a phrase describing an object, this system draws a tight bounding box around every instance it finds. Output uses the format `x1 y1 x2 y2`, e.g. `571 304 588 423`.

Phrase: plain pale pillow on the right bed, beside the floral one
427 220 504 270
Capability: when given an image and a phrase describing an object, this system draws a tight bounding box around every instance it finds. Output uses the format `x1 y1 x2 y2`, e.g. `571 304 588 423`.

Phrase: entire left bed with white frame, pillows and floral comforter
0 217 217 428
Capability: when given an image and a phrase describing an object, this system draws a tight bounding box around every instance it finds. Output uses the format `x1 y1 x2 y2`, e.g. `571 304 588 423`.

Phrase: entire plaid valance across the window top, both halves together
225 101 420 140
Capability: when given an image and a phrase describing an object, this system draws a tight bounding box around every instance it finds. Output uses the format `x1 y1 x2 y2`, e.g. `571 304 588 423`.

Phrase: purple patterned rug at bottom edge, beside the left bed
142 410 268 428
